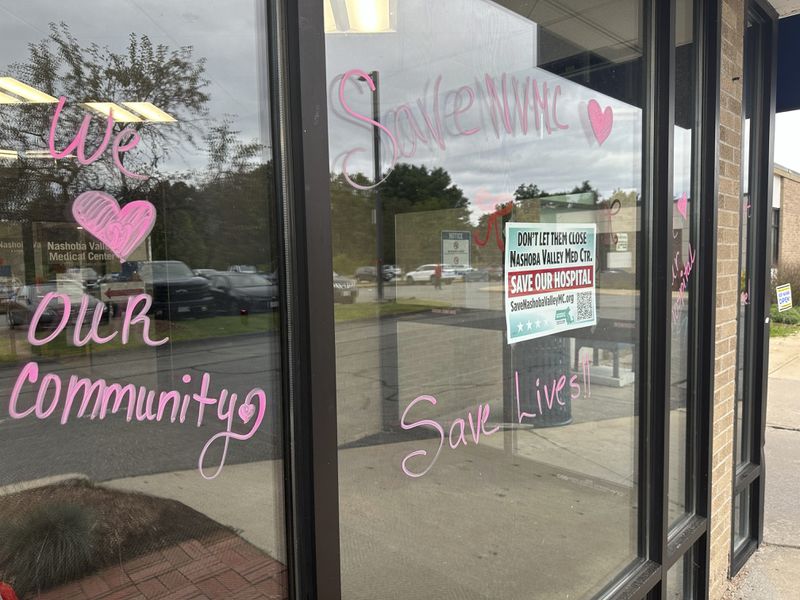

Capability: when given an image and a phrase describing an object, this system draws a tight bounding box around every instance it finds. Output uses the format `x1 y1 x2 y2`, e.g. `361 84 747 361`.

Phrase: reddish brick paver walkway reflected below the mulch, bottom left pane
37 533 287 600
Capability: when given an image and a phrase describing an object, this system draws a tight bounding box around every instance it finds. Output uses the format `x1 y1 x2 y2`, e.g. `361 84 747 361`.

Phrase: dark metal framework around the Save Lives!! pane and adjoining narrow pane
268 0 720 600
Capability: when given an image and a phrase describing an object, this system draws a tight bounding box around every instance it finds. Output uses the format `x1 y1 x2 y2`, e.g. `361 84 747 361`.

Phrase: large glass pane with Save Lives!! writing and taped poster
326 0 644 600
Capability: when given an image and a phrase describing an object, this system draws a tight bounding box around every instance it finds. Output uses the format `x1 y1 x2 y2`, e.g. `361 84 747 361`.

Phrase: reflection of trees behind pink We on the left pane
0 23 274 282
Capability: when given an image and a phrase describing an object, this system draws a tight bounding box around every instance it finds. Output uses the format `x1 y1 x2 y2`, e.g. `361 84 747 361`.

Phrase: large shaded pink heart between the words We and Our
72 191 156 262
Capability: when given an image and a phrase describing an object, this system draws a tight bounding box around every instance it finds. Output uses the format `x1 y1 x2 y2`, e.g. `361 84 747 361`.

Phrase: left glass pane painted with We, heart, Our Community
0 0 286 599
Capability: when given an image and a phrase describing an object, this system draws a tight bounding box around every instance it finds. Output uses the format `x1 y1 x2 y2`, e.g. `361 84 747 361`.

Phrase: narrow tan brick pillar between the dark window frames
709 0 745 600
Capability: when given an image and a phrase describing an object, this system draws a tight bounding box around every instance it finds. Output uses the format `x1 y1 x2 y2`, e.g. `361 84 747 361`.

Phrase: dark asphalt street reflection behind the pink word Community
0 328 280 485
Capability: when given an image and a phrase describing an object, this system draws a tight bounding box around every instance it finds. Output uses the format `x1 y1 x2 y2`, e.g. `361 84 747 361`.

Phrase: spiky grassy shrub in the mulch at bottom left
0 504 97 598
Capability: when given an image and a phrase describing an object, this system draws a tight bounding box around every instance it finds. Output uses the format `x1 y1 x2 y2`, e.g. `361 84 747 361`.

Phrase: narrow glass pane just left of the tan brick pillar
669 0 697 523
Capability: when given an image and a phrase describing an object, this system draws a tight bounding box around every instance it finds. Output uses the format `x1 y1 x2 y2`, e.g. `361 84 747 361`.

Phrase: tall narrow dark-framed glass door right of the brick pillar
731 2 777 573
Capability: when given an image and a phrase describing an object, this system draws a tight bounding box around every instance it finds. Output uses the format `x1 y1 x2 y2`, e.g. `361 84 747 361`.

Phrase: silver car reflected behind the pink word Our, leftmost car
6 279 108 328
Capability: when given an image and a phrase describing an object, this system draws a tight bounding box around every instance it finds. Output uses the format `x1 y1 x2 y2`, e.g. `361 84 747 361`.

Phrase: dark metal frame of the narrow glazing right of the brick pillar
730 0 778 576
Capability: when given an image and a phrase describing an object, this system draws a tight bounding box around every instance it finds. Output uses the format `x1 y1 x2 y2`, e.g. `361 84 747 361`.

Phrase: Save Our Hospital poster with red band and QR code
503 223 597 343
